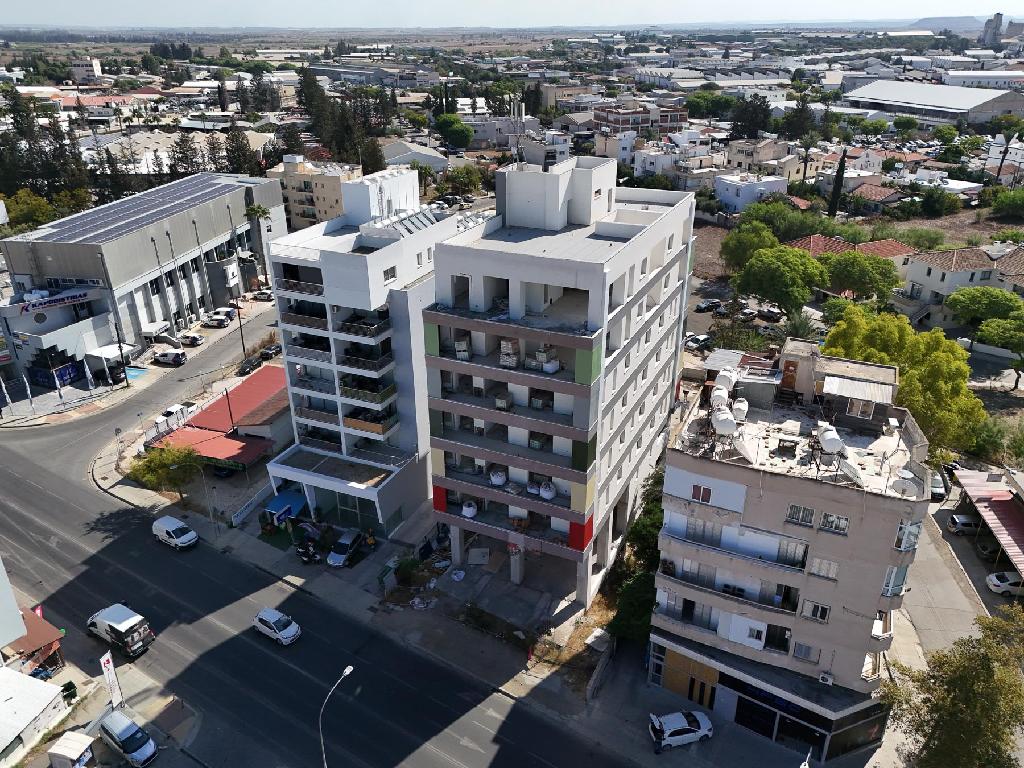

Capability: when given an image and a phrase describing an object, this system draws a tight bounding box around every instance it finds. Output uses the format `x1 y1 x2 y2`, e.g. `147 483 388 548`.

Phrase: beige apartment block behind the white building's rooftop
266 155 362 231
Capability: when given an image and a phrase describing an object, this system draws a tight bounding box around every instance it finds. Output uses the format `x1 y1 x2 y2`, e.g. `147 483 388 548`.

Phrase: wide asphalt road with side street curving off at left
0 314 624 768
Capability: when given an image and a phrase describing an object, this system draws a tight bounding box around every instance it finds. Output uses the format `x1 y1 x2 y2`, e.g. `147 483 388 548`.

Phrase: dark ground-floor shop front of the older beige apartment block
648 631 889 761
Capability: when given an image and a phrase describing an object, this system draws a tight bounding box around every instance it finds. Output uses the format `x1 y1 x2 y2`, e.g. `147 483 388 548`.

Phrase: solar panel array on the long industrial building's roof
27 173 249 243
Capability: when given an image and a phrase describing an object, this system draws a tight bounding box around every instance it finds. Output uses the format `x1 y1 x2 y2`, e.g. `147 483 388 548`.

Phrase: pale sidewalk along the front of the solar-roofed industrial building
0 301 273 428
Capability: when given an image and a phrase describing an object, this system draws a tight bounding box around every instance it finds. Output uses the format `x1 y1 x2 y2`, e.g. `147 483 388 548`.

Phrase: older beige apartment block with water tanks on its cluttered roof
648 339 931 765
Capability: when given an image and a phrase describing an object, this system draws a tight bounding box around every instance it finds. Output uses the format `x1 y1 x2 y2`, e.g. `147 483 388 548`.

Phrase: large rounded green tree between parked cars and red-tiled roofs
732 246 828 315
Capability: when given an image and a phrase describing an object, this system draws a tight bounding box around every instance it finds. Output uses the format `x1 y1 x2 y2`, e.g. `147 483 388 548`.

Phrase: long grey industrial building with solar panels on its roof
0 173 287 387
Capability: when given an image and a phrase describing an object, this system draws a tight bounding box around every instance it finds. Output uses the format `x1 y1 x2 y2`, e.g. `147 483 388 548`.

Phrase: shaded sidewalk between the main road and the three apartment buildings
93 434 925 768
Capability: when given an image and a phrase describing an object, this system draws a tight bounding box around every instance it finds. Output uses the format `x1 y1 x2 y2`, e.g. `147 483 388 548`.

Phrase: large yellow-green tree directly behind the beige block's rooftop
824 306 994 451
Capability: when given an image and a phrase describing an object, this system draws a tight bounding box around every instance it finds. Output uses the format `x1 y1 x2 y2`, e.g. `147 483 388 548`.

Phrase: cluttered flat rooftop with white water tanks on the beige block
672 403 927 500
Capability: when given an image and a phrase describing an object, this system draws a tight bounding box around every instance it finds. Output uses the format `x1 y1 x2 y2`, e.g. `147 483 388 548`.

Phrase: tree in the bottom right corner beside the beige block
882 605 1024 768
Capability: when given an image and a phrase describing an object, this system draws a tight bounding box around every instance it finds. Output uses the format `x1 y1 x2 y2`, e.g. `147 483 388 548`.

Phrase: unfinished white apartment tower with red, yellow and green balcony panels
423 157 693 605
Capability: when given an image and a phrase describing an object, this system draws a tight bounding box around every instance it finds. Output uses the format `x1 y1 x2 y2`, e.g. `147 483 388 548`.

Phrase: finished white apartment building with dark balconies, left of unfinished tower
267 169 487 537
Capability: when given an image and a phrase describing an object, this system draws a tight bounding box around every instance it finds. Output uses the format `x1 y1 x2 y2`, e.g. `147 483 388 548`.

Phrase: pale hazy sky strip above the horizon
0 0 1010 29
